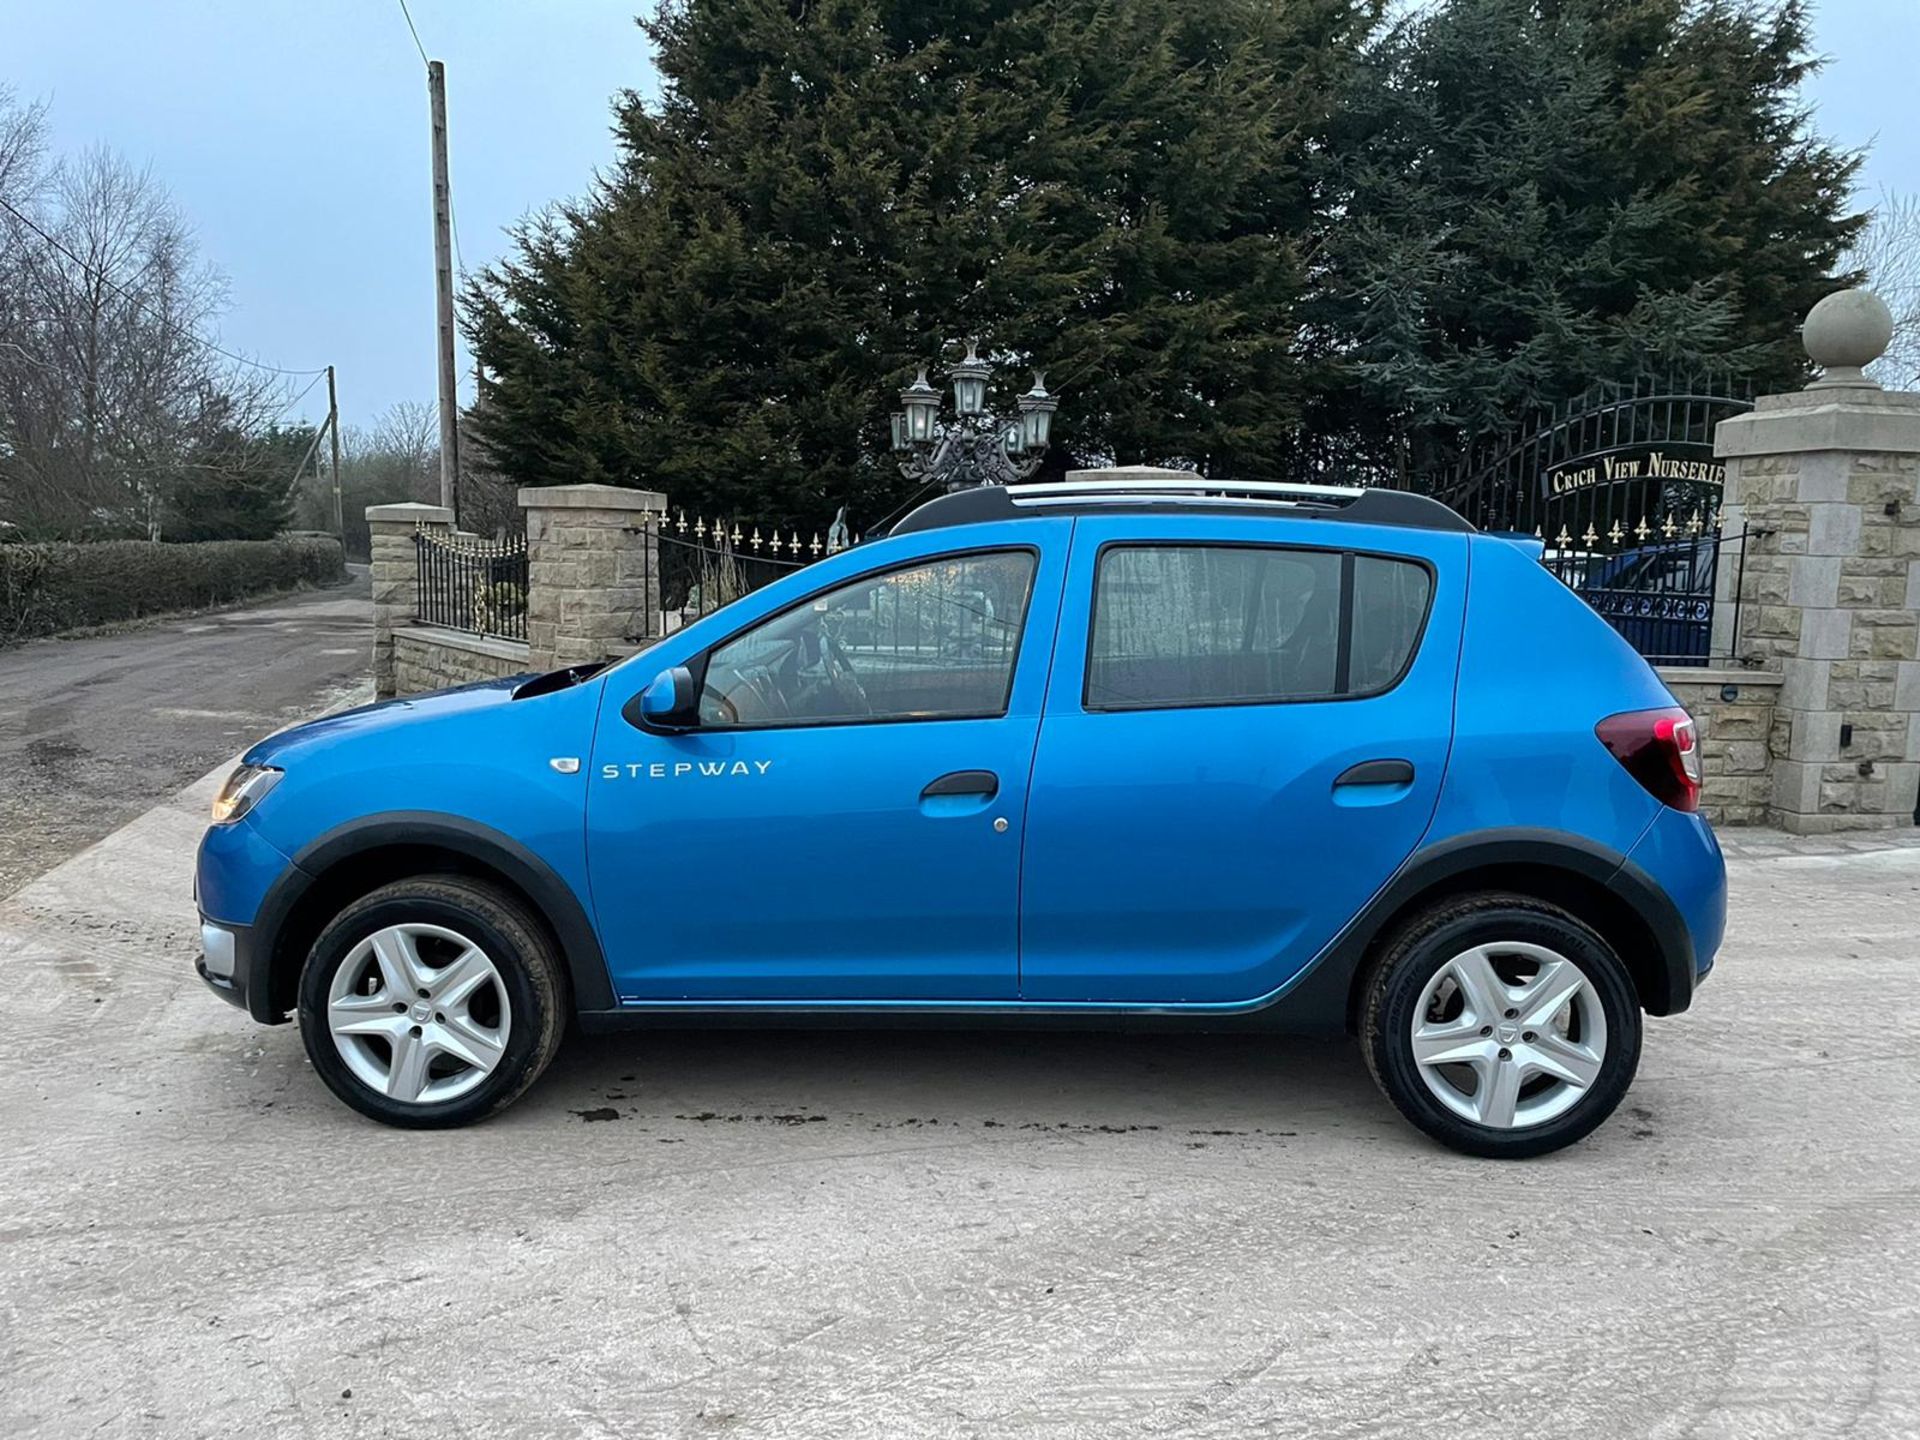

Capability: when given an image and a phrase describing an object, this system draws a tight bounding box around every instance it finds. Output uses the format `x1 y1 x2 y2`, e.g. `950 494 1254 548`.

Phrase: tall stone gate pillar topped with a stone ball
1715 290 1920 833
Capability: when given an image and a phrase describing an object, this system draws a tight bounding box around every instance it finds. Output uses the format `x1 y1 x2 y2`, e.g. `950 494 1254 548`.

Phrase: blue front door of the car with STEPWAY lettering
588 520 1071 1002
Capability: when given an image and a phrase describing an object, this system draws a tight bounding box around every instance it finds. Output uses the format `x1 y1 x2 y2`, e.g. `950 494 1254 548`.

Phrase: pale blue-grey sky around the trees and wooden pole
0 0 1920 426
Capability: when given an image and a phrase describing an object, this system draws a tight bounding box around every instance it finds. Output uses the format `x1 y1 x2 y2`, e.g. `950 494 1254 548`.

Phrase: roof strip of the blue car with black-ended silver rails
887 476 1475 536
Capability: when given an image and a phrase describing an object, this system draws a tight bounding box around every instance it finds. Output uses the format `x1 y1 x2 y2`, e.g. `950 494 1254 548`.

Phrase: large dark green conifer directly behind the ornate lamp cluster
467 0 1373 524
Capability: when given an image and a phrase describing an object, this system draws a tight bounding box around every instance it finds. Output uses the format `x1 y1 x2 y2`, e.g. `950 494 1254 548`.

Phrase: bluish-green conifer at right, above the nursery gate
1327 0 1859 476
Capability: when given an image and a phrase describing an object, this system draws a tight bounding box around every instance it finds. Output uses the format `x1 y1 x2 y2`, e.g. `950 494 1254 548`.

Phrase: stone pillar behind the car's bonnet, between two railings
520 486 666 670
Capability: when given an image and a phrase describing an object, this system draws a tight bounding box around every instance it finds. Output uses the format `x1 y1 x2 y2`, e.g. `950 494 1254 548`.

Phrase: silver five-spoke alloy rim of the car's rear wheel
1411 941 1607 1131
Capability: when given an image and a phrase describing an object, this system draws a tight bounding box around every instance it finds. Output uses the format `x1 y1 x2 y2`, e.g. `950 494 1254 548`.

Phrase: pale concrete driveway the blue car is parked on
0 778 1920 1440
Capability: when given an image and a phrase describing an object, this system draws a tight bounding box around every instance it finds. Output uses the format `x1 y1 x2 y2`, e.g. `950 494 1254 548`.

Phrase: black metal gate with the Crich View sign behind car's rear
1438 376 1753 664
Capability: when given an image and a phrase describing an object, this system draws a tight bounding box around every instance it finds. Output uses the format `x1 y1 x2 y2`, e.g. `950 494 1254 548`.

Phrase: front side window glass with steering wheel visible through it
701 549 1035 728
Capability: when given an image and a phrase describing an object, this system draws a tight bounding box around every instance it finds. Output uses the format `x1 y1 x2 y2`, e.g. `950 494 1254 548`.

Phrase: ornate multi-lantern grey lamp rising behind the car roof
893 342 1060 490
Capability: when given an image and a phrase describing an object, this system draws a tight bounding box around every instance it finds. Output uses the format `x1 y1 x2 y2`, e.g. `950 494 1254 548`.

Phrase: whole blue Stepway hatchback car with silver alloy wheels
198 480 1726 1156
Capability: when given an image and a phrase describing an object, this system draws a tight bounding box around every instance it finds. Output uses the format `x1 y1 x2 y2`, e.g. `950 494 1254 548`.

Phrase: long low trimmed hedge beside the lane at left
0 536 346 643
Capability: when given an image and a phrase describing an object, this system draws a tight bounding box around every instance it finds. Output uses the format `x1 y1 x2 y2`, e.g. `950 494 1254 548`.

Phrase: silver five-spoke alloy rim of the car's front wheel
326 924 513 1104
